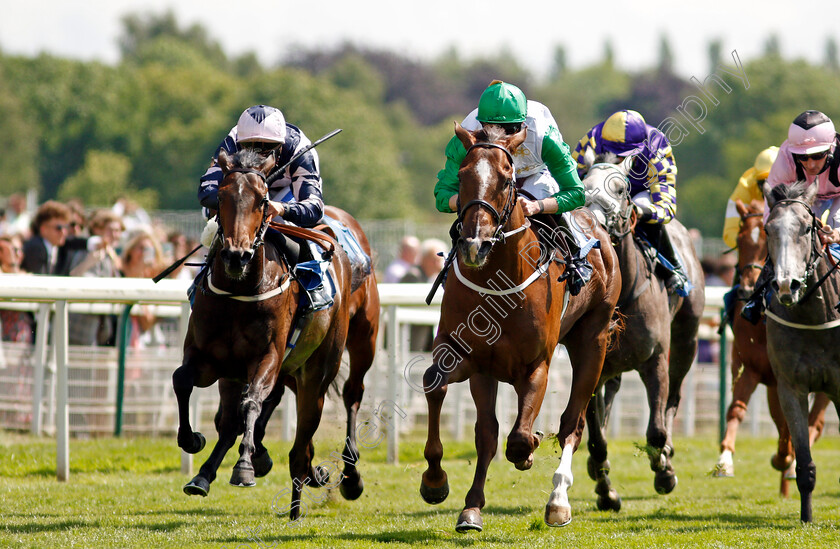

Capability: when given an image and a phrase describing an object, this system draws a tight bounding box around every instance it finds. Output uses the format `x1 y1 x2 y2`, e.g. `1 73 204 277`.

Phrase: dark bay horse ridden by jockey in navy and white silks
172 149 379 520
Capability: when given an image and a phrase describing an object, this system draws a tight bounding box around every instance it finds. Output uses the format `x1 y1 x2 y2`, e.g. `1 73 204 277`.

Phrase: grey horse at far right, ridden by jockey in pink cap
765 181 840 522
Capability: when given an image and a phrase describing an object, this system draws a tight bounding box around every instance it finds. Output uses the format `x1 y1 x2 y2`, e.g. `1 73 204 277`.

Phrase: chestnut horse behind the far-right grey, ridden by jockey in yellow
714 200 829 497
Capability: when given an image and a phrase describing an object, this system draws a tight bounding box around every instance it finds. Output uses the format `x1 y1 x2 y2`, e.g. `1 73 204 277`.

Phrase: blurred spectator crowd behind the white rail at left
0 194 196 348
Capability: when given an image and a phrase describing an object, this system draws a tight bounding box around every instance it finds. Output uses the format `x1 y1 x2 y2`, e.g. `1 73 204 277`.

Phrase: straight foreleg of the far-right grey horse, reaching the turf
778 379 817 522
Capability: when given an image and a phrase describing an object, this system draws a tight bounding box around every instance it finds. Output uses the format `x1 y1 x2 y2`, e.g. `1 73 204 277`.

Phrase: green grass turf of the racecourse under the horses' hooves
0 433 840 549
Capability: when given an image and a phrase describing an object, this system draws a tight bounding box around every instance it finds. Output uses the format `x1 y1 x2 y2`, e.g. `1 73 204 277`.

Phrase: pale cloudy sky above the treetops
0 0 840 77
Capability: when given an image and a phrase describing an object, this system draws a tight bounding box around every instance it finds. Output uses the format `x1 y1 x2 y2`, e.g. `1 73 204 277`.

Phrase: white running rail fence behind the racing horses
0 276 837 480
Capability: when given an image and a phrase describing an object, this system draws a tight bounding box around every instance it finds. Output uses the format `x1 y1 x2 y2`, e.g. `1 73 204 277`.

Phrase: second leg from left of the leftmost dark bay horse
184 379 242 496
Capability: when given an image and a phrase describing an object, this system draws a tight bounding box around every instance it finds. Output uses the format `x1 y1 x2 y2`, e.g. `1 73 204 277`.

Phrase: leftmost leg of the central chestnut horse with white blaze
420 360 468 504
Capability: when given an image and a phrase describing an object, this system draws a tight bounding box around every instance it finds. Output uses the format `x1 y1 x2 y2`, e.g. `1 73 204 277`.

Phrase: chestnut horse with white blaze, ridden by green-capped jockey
420 124 621 532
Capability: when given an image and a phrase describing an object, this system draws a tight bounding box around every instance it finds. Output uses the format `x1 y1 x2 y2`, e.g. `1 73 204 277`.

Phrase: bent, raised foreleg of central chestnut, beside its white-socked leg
505 361 548 471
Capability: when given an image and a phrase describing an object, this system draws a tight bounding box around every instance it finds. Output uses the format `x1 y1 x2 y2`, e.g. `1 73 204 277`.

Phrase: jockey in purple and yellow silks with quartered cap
572 110 691 295
